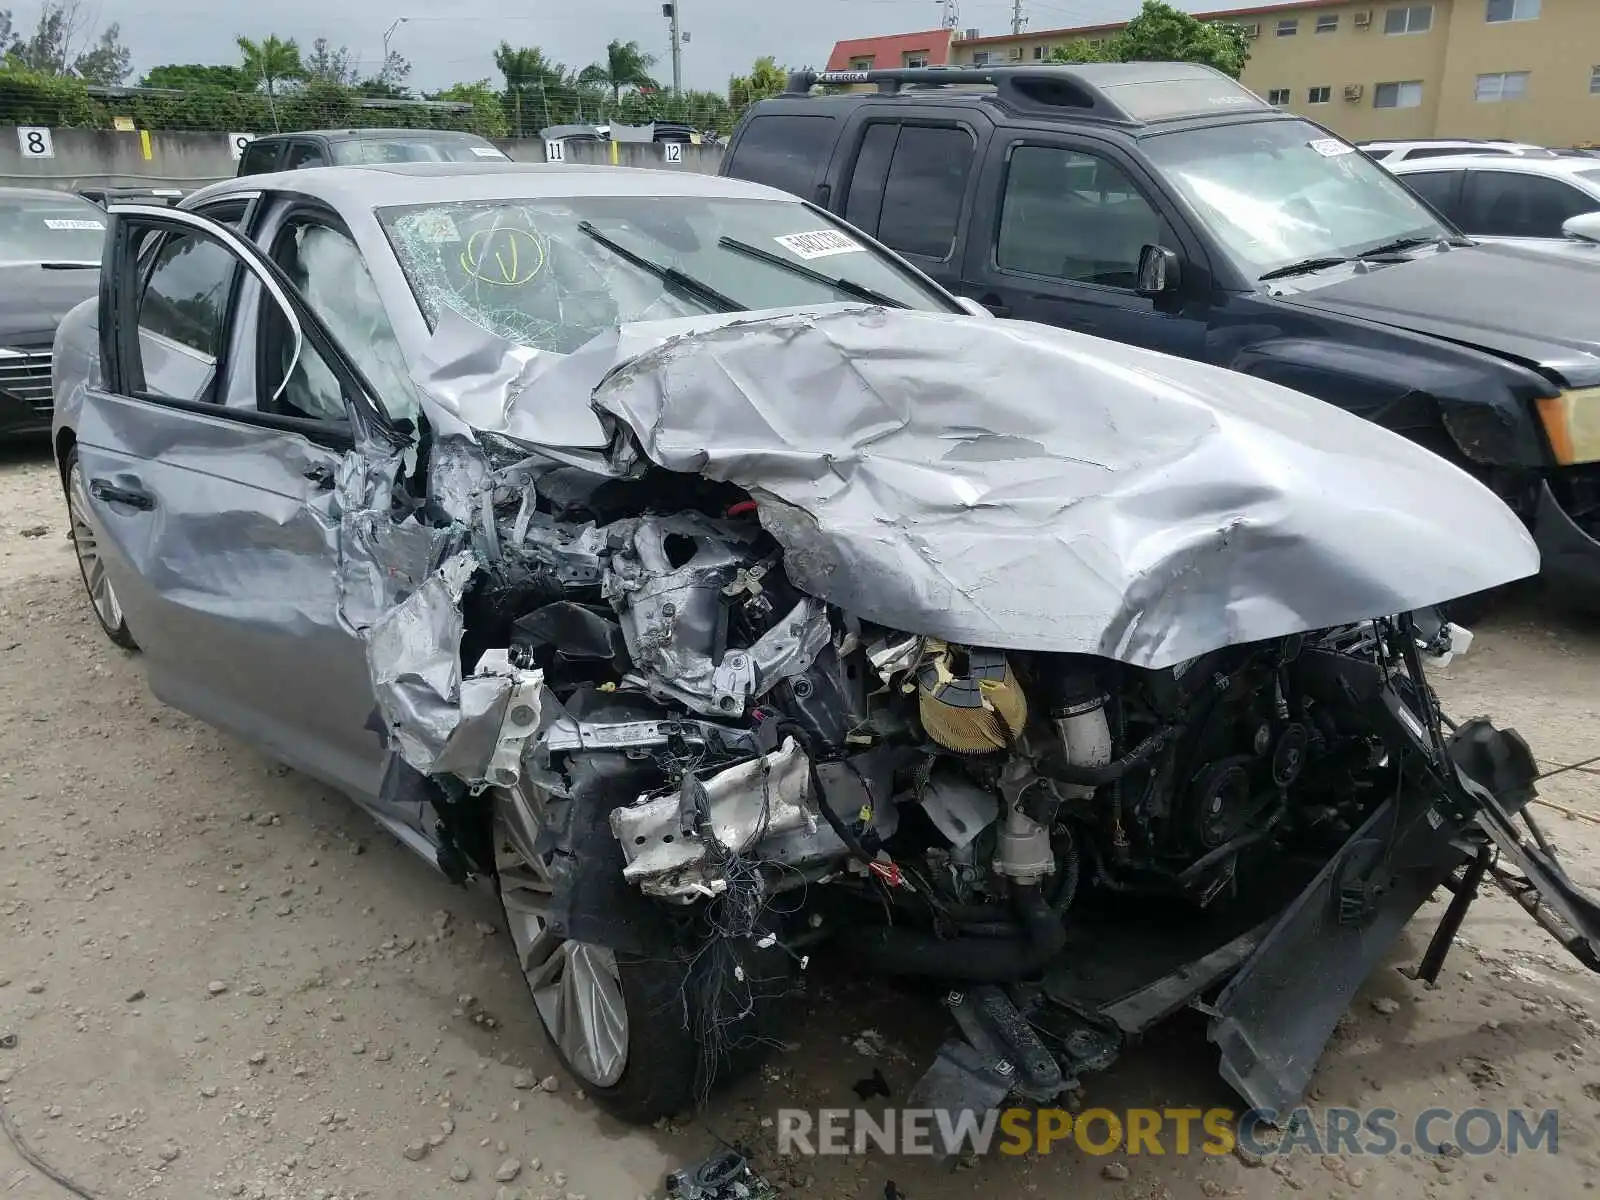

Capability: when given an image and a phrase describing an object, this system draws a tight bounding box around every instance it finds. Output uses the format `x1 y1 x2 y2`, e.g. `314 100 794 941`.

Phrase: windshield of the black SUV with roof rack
1144 122 1456 277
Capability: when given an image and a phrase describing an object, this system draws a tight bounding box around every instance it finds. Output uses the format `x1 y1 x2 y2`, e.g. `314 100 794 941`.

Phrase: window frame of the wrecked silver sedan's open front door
101 205 400 450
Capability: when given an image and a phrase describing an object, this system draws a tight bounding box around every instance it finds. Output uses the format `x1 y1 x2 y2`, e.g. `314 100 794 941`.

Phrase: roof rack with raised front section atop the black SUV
784 62 1277 125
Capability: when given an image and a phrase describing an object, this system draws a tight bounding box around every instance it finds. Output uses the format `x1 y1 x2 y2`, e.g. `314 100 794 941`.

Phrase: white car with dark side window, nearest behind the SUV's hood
1384 154 1600 242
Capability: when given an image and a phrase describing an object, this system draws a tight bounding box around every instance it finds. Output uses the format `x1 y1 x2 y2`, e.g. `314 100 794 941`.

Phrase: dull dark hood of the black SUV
1280 242 1600 386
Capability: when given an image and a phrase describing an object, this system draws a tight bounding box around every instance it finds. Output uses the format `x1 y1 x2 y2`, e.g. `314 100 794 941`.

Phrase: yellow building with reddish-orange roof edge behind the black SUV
830 0 1600 146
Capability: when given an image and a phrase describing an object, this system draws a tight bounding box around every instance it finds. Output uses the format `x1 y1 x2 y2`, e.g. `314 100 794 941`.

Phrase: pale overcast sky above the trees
28 0 1177 91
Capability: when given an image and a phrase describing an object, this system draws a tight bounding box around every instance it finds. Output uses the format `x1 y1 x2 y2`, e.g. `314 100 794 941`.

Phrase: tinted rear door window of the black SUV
878 125 974 262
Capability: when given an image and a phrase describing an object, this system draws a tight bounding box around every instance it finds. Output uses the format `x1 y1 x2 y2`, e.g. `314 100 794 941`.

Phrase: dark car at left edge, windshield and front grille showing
0 187 106 437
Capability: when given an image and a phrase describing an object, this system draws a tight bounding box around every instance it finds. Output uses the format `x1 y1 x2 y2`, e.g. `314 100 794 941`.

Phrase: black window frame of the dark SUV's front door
973 130 1211 302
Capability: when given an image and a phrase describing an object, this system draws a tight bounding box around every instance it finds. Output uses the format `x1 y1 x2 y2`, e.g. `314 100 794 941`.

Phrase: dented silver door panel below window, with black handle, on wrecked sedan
77 390 382 809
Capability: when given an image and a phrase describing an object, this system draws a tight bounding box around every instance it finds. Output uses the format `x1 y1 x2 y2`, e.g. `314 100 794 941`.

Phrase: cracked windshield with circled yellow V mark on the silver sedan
378 195 960 354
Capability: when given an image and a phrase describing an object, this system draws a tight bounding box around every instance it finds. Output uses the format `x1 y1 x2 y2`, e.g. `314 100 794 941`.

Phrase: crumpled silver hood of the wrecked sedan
416 306 1539 667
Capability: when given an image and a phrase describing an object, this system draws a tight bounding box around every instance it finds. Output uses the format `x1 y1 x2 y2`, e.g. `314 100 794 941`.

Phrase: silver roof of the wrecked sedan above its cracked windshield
182 162 802 208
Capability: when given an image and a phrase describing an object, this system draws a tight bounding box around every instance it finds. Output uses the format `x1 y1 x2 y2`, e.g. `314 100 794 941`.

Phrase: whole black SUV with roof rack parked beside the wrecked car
722 62 1600 608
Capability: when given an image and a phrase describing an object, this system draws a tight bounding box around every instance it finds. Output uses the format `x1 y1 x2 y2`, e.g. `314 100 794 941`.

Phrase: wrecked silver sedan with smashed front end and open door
54 163 1600 1122
